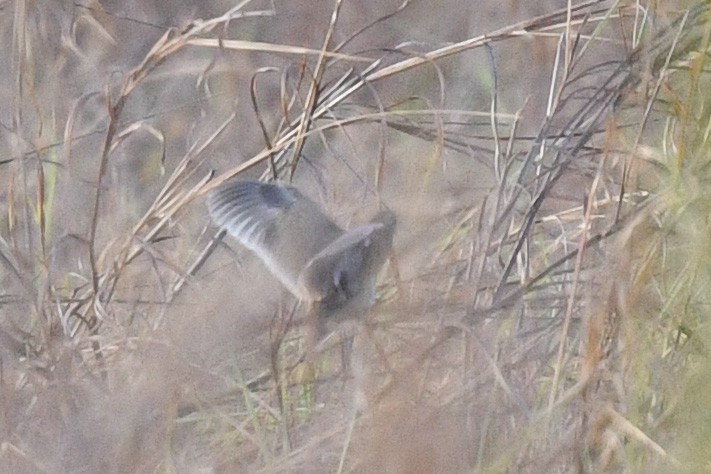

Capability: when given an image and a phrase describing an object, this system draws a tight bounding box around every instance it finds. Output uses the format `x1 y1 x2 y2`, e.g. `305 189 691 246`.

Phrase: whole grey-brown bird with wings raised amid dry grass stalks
207 180 396 319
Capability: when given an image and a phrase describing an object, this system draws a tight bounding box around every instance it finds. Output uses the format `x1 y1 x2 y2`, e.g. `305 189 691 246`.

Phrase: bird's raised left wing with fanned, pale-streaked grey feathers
207 181 343 300
